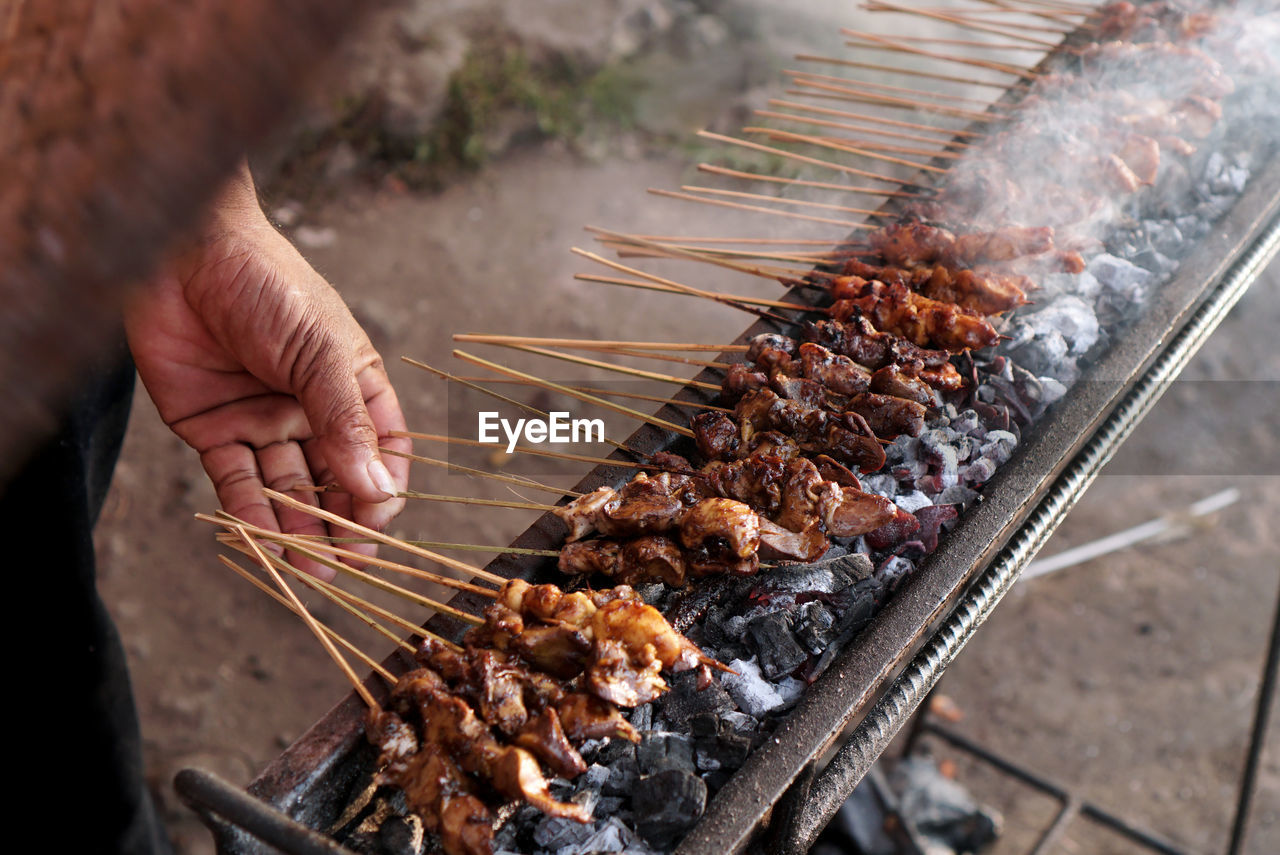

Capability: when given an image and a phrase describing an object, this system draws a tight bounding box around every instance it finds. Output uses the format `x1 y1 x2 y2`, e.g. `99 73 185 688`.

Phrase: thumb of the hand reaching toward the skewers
297 342 397 504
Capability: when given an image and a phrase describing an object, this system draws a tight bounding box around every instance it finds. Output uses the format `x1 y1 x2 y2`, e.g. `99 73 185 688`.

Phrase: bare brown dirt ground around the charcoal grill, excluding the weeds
97 3 1280 855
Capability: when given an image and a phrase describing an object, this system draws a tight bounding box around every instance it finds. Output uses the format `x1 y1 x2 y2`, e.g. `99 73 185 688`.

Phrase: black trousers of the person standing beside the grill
0 346 168 855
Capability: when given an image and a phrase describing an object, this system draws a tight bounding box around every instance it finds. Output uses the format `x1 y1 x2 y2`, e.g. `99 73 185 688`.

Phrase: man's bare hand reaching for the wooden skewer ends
125 169 410 579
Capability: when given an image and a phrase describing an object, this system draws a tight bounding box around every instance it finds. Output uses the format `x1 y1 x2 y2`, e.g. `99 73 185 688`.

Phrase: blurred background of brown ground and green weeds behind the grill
97 0 1280 855
